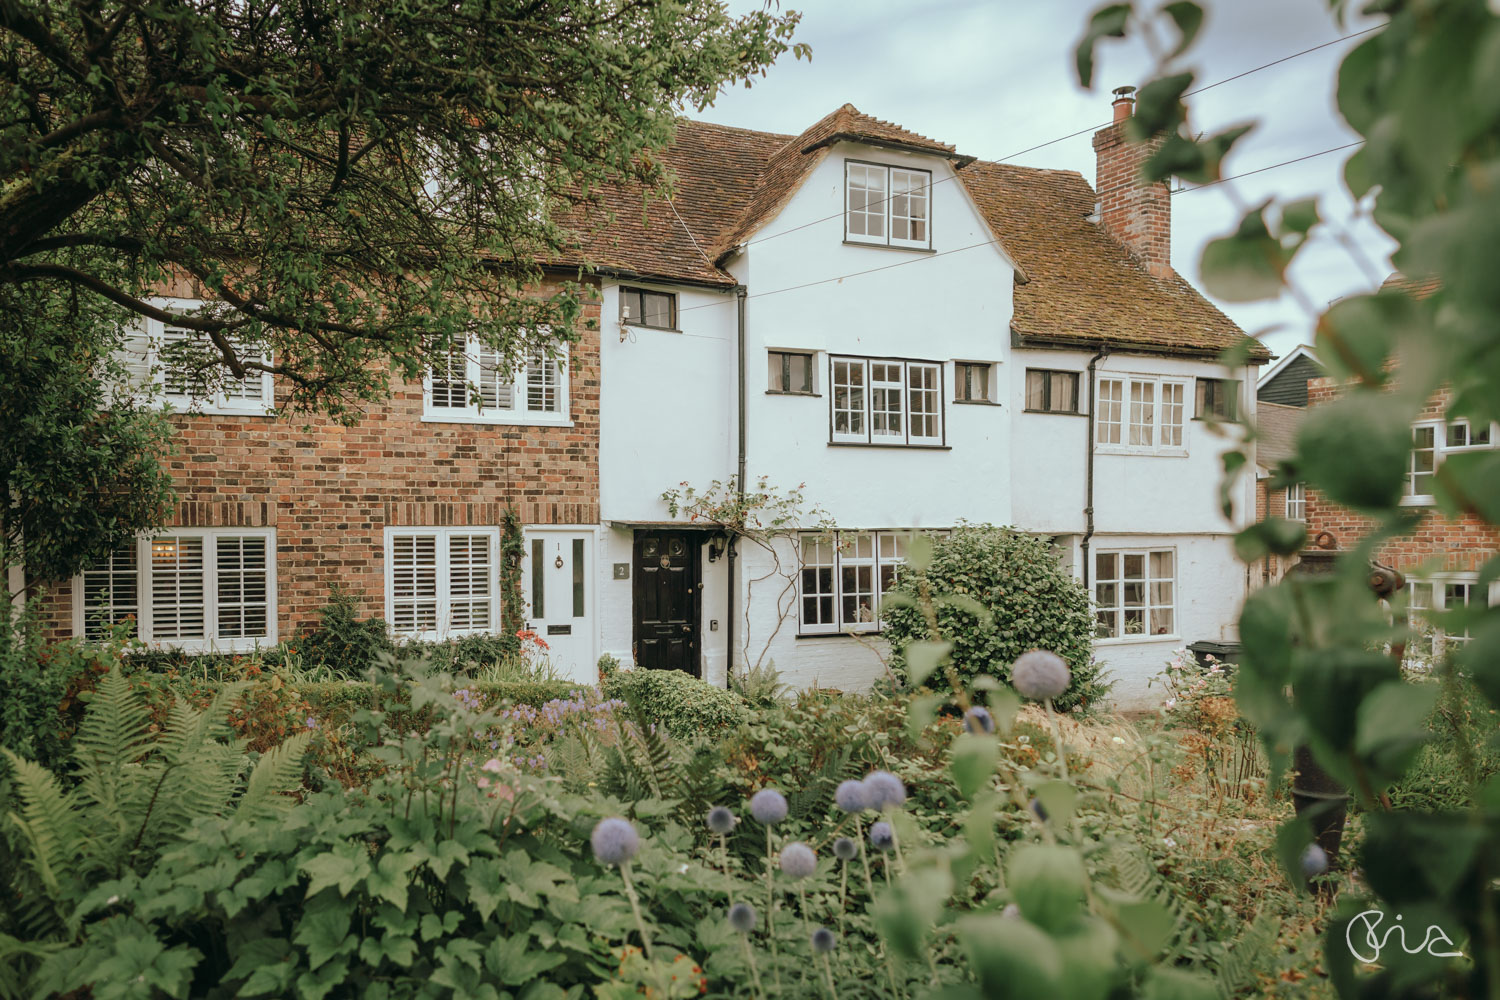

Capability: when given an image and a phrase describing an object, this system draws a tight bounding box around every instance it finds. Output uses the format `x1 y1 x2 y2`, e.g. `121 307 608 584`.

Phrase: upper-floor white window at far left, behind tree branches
120 298 276 415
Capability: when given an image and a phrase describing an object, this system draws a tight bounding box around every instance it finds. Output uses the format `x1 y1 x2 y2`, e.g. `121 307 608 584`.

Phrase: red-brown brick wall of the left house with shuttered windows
36 275 599 639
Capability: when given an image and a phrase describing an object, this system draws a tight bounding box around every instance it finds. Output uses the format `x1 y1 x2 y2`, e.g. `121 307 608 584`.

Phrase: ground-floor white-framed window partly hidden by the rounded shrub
797 531 947 636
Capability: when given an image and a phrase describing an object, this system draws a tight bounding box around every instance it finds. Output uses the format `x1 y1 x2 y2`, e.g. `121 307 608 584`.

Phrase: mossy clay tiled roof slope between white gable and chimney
959 160 1271 361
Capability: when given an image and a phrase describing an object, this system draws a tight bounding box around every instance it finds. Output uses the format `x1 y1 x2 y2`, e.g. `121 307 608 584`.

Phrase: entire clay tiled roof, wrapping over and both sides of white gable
563 105 1271 361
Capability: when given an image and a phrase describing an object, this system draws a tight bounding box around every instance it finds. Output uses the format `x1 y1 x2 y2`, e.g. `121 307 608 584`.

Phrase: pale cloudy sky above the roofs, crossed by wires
695 0 1392 365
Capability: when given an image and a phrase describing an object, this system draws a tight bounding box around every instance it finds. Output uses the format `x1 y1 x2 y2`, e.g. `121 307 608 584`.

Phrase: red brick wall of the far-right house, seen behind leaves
1307 378 1500 573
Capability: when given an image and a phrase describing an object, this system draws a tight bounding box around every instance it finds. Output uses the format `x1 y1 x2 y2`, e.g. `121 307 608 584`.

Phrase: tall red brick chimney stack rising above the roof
1094 87 1173 277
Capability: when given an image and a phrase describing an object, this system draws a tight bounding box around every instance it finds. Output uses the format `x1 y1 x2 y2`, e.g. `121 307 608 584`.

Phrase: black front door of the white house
635 531 701 678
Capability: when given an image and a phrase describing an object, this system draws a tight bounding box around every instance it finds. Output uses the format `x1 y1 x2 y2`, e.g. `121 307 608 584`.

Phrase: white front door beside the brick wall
521 528 599 684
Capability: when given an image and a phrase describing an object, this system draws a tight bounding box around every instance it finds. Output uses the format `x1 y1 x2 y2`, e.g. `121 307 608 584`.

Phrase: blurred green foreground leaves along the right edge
1079 0 1500 997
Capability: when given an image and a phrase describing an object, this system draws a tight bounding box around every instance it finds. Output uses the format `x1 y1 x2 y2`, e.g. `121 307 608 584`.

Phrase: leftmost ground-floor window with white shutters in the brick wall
74 528 276 652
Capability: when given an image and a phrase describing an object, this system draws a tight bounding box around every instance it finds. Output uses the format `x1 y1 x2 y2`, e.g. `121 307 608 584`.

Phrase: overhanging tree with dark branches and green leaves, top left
0 0 806 418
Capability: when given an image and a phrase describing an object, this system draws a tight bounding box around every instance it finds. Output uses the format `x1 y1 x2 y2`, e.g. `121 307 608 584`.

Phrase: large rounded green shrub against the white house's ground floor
885 525 1107 711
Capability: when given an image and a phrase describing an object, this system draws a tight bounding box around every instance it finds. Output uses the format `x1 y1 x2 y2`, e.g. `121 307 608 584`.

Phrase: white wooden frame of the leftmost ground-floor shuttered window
72 528 278 654
